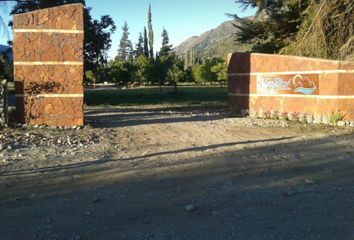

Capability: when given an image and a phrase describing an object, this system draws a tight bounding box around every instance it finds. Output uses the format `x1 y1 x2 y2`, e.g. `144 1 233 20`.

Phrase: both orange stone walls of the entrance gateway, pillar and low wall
13 4 354 126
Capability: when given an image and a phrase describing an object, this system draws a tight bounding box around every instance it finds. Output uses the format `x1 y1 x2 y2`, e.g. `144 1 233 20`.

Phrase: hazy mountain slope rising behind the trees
175 20 247 59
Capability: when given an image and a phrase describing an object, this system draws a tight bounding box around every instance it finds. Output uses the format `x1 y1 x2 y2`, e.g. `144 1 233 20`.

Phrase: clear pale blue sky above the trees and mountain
0 0 255 58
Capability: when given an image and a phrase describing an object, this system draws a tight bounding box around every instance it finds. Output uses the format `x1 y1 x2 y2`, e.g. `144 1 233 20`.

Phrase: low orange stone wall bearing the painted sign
228 53 354 122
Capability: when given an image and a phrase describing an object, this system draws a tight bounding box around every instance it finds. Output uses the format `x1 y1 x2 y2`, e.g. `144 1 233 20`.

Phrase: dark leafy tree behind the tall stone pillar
10 0 116 80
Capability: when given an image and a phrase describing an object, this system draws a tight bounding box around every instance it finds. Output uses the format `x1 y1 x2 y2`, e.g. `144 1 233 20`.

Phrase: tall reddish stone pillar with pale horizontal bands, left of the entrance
13 4 84 126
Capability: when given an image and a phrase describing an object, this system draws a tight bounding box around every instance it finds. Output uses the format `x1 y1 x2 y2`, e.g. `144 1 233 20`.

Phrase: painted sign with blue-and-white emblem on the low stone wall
257 74 319 95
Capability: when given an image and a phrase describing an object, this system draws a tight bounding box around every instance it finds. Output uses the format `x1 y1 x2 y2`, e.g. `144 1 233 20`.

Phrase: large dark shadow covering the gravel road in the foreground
0 129 354 240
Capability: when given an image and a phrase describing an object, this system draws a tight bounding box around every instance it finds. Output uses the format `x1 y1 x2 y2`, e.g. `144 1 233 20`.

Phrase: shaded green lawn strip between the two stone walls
85 87 227 106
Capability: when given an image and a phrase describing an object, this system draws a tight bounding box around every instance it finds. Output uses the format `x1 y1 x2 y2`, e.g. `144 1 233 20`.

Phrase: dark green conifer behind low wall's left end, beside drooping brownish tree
235 0 311 53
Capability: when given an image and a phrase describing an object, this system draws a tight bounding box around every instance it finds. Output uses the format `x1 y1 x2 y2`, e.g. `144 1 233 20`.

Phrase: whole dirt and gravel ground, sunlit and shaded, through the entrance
0 106 354 240
